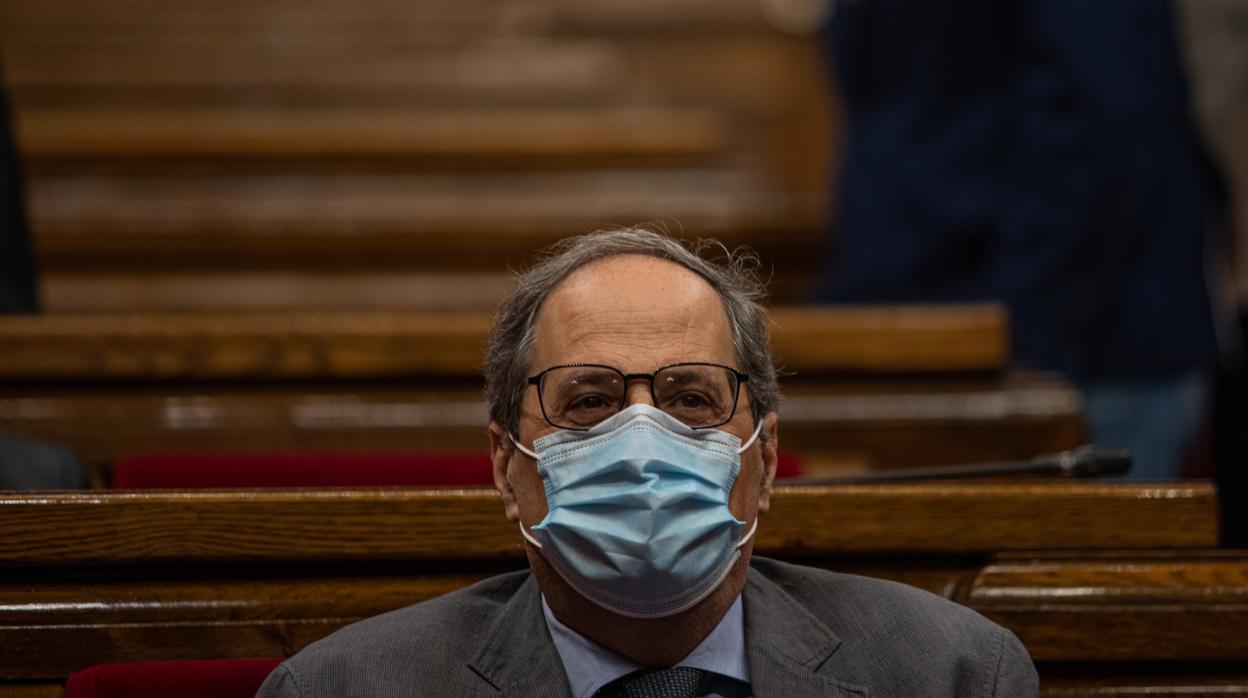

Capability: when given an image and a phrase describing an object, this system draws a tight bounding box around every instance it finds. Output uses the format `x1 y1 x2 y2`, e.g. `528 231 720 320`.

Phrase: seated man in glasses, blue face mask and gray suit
260 230 1037 698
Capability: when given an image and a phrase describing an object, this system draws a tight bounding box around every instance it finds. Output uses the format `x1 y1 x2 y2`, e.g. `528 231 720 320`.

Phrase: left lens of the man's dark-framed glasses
540 366 624 428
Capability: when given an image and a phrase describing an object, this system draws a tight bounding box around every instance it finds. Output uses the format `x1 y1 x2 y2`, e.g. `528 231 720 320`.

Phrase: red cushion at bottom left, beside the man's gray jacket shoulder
65 659 282 698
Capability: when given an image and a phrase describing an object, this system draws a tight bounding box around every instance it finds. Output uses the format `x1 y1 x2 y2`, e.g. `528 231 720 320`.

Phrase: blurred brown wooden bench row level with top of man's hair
30 169 822 273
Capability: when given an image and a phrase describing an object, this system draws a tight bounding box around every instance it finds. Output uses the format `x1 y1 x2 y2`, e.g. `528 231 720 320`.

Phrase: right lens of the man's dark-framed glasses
654 363 736 427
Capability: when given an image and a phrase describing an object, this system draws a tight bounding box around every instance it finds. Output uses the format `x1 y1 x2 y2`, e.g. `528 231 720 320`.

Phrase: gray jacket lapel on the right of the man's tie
743 568 867 698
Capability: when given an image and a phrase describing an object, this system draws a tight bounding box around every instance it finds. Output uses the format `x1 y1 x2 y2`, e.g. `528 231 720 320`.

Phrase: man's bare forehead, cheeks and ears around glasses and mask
490 255 776 611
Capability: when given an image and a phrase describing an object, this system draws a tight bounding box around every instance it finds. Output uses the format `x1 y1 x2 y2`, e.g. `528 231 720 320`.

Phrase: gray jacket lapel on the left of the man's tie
468 574 572 698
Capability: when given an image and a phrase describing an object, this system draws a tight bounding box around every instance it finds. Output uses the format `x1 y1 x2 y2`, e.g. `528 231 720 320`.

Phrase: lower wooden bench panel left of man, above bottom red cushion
0 571 496 679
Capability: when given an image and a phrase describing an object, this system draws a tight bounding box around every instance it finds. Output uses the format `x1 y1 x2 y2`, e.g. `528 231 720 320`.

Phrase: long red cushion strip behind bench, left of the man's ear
112 452 494 488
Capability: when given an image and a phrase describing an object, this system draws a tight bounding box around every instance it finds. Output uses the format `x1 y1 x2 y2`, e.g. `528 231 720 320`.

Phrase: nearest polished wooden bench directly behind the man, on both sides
0 483 1248 696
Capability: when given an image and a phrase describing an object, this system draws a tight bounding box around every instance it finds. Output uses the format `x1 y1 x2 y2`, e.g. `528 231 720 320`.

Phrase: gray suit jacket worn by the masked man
258 558 1038 698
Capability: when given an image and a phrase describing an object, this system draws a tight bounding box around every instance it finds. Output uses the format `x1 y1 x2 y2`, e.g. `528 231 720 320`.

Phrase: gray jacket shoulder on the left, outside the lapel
257 571 529 698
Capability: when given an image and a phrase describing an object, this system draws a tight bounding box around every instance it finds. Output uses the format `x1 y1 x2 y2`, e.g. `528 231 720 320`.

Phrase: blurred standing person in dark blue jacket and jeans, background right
819 0 1231 479
